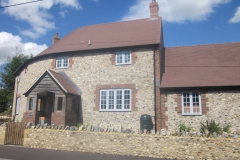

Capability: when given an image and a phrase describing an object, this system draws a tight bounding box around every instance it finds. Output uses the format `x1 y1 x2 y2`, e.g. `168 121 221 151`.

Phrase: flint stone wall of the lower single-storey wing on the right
165 91 240 132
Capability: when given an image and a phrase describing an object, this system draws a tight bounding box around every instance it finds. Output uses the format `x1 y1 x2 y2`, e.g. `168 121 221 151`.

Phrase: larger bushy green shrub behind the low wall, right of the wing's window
200 120 223 137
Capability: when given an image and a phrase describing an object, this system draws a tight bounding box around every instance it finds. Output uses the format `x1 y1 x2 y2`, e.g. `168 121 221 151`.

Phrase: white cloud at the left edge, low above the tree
0 32 47 65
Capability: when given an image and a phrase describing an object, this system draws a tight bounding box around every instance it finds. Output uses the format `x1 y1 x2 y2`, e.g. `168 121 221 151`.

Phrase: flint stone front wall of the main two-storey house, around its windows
14 49 154 129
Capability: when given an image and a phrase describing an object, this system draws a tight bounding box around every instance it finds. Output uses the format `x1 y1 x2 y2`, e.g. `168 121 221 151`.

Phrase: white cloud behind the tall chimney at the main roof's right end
122 0 231 23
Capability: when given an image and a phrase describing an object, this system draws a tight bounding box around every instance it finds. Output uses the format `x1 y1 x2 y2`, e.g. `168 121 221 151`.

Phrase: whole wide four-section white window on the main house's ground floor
100 89 131 111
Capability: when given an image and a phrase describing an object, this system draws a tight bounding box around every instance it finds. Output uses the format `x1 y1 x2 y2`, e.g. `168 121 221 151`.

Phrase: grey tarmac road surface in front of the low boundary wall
0 145 172 160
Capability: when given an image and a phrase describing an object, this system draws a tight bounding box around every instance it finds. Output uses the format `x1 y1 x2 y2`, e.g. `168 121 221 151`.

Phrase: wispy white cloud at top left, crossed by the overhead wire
0 0 82 39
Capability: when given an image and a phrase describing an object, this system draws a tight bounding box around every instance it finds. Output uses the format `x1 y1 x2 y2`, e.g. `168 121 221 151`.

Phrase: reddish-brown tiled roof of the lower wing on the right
161 43 240 88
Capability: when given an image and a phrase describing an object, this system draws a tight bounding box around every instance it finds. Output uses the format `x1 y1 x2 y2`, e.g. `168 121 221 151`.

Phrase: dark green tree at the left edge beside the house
0 48 29 112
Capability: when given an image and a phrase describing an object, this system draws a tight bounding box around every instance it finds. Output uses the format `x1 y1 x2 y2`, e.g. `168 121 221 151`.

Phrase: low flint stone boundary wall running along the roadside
24 129 240 160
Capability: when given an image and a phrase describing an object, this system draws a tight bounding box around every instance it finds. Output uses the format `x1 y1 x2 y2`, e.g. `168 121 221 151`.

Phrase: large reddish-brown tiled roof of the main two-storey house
38 17 162 56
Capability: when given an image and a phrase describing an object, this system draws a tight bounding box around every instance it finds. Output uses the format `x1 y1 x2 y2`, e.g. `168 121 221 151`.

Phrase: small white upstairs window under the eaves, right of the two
116 51 132 65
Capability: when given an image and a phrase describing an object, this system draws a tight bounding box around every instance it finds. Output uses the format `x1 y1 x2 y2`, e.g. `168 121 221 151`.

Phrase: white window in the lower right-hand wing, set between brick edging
182 92 202 115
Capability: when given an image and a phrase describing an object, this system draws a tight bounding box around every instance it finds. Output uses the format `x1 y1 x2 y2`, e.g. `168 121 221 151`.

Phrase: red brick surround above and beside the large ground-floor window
93 84 138 111
